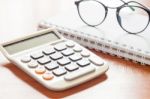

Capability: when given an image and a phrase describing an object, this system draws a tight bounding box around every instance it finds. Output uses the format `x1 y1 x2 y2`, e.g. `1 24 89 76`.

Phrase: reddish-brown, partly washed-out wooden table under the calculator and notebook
0 0 150 99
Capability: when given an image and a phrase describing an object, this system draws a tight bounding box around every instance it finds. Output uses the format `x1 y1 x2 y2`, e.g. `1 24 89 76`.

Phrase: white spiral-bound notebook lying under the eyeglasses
39 8 150 65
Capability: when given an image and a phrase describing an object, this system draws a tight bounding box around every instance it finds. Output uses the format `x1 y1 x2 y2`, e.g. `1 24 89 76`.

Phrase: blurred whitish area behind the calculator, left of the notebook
0 0 71 42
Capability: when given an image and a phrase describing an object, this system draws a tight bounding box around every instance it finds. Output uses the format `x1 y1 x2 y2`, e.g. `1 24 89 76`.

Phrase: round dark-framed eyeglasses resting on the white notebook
75 0 150 34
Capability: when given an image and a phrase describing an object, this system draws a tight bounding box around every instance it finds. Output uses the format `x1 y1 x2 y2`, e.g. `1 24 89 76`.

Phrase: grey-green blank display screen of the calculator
4 32 60 54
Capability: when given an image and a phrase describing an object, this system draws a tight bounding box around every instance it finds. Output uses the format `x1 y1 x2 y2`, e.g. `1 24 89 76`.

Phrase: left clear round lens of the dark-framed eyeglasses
79 0 106 25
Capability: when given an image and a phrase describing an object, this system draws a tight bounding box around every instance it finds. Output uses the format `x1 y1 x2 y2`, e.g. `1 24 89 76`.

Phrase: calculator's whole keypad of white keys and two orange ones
21 41 104 80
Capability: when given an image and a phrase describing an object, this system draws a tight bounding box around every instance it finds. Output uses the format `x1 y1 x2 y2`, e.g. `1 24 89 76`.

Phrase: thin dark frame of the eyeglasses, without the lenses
75 0 150 34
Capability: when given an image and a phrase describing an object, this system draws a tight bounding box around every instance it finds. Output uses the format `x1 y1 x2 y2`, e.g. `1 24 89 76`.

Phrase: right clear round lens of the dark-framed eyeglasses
119 6 149 33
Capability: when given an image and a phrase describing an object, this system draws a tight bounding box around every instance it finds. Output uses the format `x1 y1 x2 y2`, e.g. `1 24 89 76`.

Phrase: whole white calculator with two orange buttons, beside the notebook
0 28 108 91
